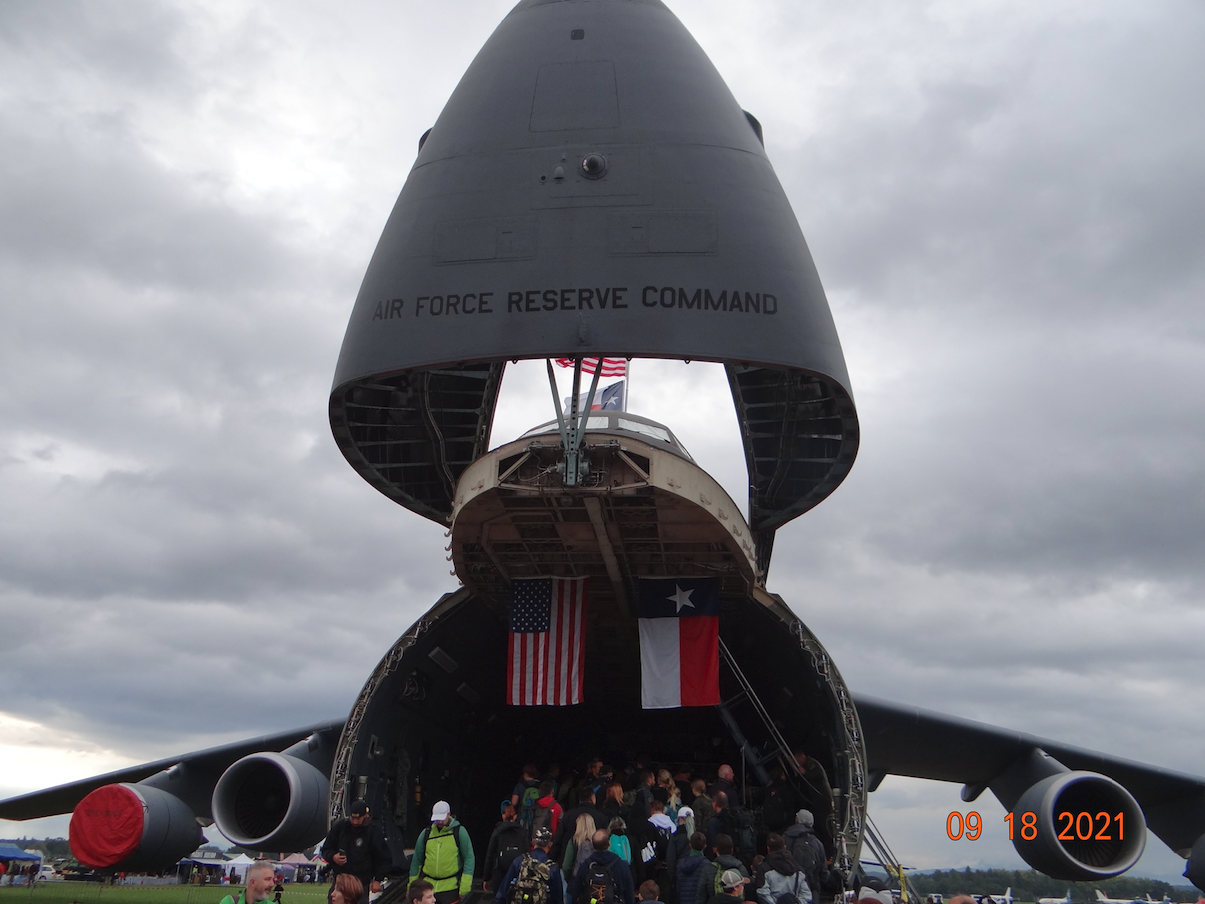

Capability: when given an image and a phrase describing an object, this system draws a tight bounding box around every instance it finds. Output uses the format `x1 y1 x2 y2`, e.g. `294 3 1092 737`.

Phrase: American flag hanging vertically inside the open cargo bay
506 577 586 706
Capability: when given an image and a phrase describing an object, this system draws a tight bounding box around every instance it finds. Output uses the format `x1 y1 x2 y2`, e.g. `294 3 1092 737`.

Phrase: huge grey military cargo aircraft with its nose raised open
0 0 1205 888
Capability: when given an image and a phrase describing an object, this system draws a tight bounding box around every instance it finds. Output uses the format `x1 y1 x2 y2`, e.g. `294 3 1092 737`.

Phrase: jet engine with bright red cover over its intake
70 783 205 870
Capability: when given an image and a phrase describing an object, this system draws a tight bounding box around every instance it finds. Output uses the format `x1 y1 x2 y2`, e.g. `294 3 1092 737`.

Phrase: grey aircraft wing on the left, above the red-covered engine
0 720 343 820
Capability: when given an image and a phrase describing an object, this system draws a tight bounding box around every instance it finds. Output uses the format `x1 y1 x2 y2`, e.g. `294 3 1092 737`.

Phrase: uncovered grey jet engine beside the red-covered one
213 752 330 851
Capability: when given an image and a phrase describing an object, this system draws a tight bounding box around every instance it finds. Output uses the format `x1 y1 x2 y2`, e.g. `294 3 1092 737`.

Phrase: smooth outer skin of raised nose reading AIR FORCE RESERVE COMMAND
335 0 847 385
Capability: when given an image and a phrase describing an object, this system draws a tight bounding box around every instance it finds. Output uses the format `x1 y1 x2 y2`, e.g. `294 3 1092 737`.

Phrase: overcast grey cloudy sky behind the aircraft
0 0 1205 892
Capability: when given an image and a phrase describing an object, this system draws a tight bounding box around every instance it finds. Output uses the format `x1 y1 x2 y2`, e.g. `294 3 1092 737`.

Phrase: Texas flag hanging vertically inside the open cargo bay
640 577 719 710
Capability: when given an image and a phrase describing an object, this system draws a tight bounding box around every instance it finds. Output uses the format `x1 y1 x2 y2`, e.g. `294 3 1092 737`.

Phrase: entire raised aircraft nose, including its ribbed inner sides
330 0 858 549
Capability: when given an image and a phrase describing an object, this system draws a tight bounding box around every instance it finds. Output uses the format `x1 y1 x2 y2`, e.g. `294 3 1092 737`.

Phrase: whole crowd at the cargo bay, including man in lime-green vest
295 753 853 904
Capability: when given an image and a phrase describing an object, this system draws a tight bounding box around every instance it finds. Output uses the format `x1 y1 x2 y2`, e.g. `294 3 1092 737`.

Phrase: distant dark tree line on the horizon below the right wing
906 867 1200 904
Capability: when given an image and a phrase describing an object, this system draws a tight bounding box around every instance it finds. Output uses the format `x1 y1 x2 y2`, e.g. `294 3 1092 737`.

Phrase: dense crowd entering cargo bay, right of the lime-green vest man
469 755 841 904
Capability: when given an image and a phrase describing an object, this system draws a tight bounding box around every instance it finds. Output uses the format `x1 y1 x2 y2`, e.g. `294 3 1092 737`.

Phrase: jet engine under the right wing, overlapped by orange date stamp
1012 771 1146 882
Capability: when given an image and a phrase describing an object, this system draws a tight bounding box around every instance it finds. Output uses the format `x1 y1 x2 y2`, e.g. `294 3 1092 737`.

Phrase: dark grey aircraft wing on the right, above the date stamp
854 694 1205 856
